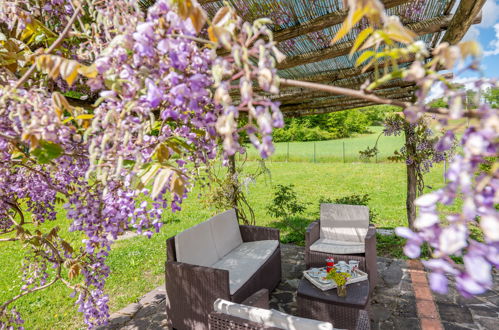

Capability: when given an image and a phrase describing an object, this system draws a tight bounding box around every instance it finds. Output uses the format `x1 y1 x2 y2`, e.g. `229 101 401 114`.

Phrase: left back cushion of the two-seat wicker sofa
175 222 219 266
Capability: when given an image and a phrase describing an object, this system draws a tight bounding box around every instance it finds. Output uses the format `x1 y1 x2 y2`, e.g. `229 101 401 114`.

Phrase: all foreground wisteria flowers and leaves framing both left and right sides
0 0 499 329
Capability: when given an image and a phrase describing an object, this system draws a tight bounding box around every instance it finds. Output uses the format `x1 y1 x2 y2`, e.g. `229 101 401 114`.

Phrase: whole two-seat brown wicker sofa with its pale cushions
166 210 281 330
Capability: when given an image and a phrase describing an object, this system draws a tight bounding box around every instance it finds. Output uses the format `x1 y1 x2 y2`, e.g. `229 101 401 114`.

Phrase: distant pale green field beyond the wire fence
243 126 404 163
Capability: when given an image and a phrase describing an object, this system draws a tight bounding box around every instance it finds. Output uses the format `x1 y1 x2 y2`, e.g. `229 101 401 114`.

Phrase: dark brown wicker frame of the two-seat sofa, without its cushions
165 210 281 330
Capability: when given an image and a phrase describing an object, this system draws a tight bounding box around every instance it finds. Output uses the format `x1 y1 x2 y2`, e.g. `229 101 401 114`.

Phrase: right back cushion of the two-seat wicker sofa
208 209 243 258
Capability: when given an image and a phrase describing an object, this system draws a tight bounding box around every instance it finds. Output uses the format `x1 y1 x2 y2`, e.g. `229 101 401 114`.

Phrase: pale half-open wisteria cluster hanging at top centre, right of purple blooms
212 8 284 158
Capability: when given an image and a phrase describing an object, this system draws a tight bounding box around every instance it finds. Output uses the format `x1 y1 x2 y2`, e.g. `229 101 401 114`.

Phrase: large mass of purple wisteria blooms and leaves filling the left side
0 0 283 328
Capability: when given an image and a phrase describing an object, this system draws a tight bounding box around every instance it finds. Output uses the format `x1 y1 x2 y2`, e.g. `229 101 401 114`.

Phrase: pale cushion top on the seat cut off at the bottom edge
213 299 334 330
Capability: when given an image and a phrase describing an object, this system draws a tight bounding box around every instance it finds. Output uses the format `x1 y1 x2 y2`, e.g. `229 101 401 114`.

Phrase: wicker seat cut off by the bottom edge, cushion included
209 289 370 330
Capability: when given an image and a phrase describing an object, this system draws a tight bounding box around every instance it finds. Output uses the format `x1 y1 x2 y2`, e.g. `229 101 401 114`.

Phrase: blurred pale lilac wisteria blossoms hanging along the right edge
397 43 499 296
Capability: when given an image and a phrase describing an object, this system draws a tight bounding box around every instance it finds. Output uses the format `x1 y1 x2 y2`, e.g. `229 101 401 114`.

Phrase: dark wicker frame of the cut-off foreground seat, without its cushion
208 289 370 330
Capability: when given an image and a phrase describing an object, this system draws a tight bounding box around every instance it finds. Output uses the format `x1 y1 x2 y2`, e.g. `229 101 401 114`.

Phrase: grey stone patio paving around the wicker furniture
101 244 499 330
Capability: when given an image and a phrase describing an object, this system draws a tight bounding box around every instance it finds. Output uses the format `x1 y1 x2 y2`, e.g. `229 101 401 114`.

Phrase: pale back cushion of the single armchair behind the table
320 203 369 242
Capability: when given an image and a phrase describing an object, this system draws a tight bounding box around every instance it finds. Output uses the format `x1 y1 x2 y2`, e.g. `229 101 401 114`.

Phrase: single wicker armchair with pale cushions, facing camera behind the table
305 203 378 293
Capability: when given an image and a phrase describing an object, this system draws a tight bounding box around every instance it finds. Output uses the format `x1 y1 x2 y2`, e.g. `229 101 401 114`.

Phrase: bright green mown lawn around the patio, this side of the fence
0 162 454 329
